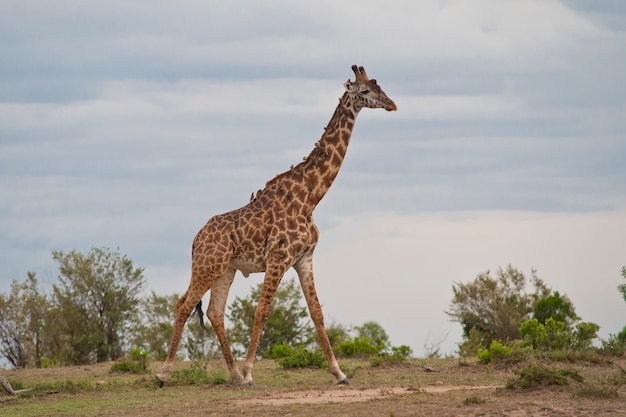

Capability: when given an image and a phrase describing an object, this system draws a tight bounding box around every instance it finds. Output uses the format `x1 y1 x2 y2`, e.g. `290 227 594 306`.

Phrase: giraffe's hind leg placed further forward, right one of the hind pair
206 268 243 382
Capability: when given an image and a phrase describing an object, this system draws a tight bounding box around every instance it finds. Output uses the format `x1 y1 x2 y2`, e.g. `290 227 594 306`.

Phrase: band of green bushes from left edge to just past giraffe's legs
0 248 411 374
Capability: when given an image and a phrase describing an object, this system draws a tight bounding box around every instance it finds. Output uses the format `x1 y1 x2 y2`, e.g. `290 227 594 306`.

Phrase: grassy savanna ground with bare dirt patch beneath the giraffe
0 358 626 417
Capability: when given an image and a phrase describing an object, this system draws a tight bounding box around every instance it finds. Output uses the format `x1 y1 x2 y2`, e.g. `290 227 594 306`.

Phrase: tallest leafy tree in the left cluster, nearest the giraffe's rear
52 248 144 364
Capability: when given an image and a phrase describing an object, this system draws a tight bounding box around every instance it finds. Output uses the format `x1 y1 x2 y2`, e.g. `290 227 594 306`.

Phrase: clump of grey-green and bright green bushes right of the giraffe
447 265 626 364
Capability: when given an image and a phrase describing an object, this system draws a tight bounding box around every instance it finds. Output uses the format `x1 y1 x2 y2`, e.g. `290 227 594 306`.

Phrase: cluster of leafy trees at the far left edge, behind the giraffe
0 248 144 368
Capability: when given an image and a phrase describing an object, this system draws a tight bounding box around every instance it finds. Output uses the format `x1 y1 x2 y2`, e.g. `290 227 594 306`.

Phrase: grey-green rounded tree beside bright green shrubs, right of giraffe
446 265 550 355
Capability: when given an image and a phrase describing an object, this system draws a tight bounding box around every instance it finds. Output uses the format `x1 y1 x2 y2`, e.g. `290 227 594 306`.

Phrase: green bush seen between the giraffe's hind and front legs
227 279 314 355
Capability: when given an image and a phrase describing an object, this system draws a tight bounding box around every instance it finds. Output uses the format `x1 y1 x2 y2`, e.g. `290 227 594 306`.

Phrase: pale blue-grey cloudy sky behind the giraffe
0 0 626 355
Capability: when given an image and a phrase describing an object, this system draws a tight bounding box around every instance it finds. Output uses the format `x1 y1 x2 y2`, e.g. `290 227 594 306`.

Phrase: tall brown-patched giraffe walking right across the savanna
157 65 396 385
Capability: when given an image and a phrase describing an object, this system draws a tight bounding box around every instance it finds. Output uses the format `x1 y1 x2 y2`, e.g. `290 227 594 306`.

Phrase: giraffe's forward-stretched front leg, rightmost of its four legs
294 258 350 384
